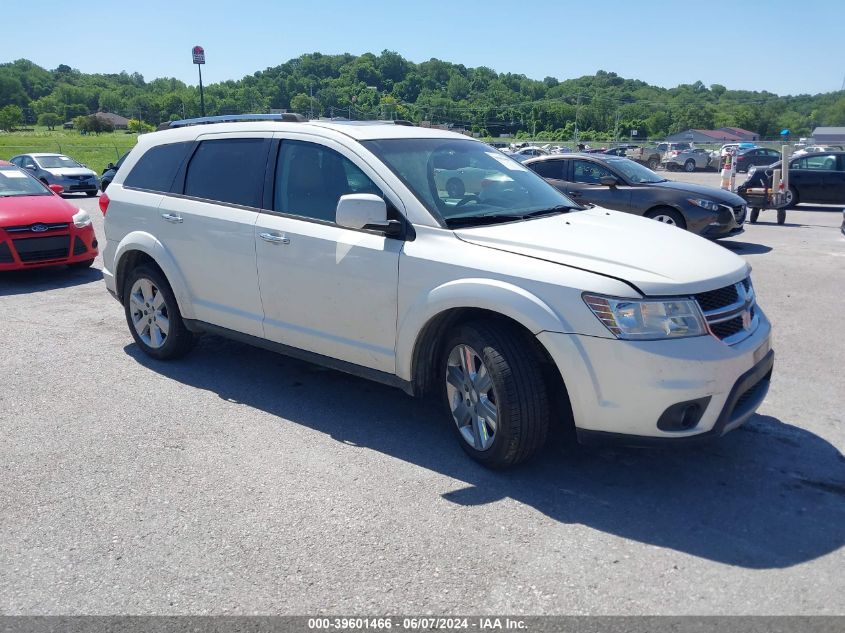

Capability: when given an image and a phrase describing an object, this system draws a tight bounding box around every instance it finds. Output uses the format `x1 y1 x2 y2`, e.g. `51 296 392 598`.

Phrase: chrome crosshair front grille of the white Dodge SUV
694 278 760 345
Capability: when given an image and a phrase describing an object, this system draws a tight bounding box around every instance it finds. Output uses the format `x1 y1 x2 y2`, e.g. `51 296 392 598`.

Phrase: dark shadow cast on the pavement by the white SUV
124 336 845 569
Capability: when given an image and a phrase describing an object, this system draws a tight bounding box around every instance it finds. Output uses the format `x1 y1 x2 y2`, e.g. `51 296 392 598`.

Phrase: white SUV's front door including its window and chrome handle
255 139 404 374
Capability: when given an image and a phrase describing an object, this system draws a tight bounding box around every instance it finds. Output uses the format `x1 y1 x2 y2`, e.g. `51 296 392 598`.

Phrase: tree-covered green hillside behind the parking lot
0 51 845 140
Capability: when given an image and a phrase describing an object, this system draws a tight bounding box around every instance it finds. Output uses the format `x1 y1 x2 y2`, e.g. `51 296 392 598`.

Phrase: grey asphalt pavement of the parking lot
0 173 845 615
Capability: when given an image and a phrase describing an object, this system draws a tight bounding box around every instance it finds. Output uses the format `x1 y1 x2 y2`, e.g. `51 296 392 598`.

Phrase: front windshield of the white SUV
363 138 580 226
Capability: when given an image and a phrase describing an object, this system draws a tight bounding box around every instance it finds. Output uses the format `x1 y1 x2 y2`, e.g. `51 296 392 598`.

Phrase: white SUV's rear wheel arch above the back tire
114 231 194 319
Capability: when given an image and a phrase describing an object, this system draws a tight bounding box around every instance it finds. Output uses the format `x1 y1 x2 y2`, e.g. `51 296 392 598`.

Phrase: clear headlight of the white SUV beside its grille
584 294 707 341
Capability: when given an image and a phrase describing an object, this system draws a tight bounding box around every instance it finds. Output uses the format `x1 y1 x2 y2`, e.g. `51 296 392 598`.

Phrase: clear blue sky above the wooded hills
6 0 845 95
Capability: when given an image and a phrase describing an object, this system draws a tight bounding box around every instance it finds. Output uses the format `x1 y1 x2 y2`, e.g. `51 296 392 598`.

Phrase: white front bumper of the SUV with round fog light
538 311 774 443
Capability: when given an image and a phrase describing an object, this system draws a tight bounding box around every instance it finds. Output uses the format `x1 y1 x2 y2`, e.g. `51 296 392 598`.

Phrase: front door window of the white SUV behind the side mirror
273 141 381 222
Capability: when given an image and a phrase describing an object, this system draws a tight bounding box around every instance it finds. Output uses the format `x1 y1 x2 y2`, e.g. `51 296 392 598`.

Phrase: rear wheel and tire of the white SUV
123 266 195 360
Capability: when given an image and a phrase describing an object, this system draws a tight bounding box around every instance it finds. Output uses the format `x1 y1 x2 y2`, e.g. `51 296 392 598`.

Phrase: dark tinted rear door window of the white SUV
185 138 270 207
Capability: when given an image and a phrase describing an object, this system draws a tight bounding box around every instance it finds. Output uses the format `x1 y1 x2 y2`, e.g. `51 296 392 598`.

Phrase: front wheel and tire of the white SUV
440 322 550 468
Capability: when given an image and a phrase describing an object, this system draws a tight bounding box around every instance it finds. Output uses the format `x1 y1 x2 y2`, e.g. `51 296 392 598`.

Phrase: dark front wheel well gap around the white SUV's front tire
411 308 574 433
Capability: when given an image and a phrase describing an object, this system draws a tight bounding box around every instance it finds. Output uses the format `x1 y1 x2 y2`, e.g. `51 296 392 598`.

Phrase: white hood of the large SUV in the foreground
455 207 750 295
